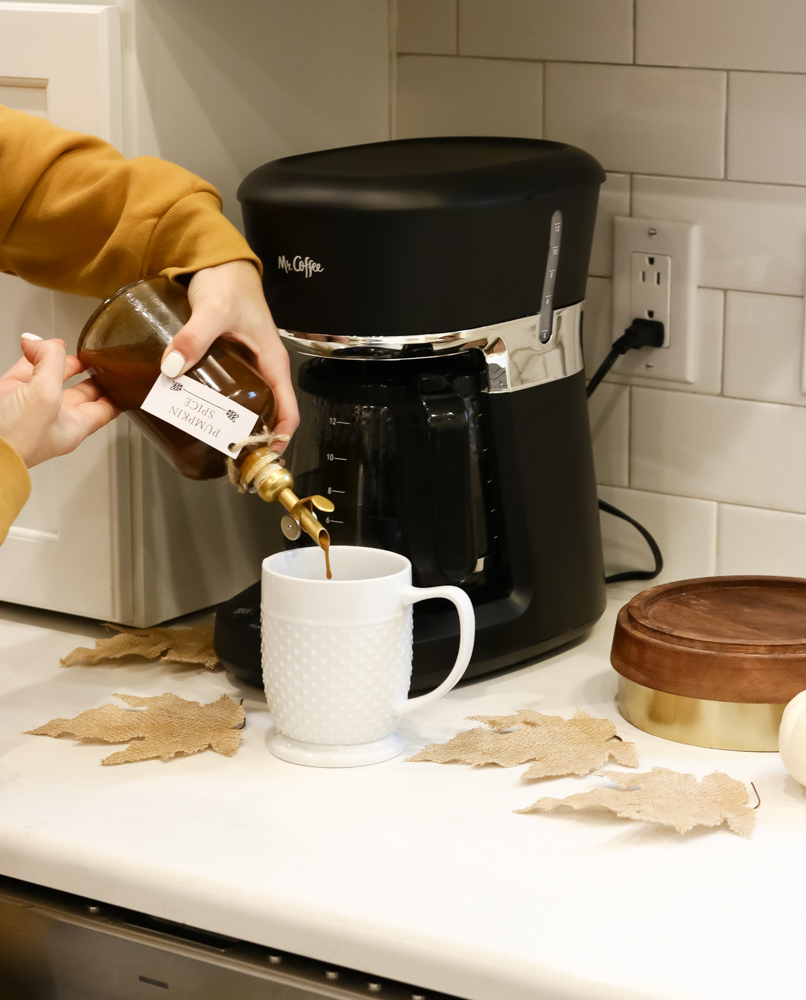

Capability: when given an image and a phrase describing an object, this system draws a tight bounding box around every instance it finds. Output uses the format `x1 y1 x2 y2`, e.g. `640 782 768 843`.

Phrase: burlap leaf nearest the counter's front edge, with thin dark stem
515 767 756 837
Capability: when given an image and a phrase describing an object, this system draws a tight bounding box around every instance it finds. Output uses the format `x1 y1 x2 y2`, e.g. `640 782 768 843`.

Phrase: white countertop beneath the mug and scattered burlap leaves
0 586 806 1000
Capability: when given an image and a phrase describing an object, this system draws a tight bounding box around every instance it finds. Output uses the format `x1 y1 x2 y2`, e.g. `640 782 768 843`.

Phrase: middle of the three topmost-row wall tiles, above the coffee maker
459 0 633 63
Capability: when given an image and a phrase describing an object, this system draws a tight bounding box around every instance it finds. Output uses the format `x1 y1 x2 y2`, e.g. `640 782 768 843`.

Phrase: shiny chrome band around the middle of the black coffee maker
280 301 585 393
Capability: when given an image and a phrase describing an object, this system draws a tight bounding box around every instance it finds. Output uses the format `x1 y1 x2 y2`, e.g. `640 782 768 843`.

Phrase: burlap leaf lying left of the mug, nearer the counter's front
28 693 246 764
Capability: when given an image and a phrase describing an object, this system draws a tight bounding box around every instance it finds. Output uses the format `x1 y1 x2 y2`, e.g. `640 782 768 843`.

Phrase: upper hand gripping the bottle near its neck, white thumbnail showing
162 260 299 451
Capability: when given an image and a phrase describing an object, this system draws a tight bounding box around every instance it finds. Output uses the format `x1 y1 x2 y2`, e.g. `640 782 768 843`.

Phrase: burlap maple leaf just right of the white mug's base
409 709 638 780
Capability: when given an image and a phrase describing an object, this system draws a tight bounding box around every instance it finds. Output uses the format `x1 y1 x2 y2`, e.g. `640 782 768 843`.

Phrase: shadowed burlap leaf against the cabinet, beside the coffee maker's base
61 625 221 670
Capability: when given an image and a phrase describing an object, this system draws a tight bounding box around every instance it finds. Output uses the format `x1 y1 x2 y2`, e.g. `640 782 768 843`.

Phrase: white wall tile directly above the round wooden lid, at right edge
717 504 806 576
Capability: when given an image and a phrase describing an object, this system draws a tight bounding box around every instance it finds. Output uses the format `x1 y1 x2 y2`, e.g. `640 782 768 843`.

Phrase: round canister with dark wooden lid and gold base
610 576 806 750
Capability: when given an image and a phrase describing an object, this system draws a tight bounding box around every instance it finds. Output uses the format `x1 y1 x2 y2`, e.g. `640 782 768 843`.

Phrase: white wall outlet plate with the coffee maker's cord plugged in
612 216 700 382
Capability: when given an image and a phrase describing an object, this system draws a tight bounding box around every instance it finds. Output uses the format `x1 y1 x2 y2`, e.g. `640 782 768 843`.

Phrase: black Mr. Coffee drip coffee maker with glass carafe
215 138 605 689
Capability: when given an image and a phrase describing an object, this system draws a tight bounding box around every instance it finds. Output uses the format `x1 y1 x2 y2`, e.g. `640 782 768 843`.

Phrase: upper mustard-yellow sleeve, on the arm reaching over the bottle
0 106 260 298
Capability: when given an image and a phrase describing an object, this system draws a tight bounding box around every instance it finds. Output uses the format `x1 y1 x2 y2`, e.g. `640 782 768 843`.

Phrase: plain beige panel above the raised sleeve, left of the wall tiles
17 0 390 226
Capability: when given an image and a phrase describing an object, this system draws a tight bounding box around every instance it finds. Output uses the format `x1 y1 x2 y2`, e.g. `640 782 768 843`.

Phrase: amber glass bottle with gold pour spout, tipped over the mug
77 277 332 579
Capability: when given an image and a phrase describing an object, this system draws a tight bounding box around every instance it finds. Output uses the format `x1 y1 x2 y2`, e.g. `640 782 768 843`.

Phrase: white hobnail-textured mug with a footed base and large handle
261 545 475 767
